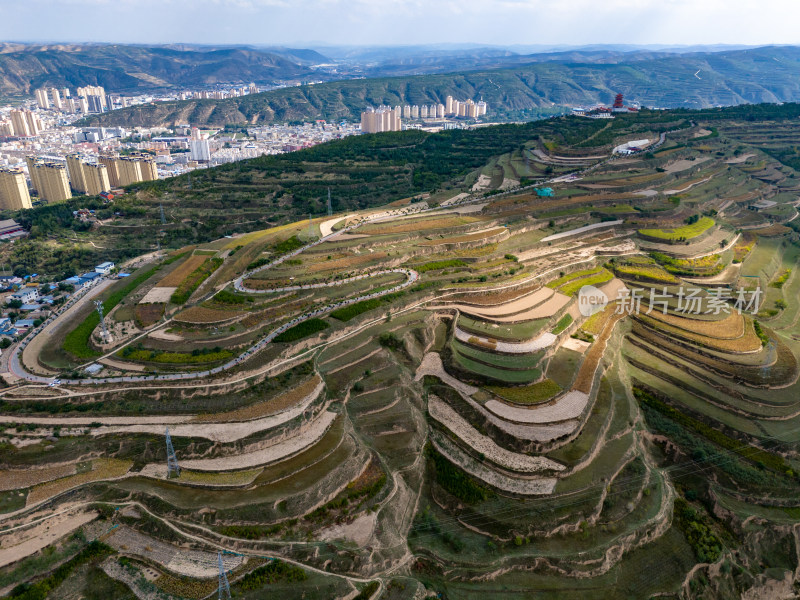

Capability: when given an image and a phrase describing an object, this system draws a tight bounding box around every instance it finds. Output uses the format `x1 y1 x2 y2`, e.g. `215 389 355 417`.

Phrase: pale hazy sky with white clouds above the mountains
0 0 800 45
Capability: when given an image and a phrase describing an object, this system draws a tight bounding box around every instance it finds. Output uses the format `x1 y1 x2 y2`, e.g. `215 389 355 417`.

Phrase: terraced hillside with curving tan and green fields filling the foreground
0 106 800 600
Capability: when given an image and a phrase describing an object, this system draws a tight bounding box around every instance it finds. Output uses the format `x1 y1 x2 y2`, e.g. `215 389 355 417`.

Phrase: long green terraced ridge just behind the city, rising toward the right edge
75 46 800 126
